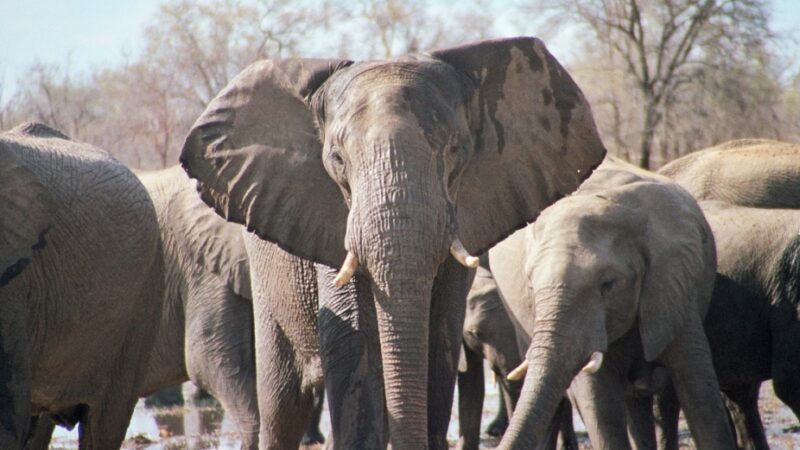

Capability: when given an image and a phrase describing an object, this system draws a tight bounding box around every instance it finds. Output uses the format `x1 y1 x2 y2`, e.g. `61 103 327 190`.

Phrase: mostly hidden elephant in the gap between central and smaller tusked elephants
458 267 523 449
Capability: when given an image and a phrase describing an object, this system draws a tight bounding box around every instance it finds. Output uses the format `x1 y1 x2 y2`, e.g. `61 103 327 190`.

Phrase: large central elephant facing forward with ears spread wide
180 37 606 450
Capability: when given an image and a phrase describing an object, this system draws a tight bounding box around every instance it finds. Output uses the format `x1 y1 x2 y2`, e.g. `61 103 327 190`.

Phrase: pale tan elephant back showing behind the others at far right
658 139 800 208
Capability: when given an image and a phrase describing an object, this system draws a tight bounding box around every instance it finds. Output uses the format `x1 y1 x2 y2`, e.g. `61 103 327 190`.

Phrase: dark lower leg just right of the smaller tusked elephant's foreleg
724 383 769 450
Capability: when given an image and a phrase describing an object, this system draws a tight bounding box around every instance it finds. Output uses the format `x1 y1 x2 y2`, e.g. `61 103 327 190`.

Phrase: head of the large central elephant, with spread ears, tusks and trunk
181 38 605 448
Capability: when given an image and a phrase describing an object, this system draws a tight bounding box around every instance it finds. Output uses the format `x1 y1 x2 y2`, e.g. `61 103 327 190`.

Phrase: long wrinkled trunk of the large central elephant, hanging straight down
347 167 454 450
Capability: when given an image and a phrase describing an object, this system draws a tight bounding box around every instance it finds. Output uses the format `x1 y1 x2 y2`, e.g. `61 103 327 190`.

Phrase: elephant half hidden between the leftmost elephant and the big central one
24 165 259 449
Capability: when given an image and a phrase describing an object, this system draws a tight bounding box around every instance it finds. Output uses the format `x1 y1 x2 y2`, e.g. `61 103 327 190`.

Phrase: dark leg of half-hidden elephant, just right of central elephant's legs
458 345 484 450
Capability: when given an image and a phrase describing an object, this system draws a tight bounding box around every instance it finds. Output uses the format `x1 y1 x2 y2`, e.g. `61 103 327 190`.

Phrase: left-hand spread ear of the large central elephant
181 59 350 266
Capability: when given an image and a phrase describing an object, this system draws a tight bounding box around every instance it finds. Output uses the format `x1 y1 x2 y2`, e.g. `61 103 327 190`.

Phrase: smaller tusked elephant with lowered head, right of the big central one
489 158 733 449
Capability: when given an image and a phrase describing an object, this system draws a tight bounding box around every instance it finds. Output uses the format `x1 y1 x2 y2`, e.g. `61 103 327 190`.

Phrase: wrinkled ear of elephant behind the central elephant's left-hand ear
167 174 253 299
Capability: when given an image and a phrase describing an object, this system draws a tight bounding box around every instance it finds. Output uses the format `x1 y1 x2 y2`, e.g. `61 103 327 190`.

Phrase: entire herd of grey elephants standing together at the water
0 37 800 450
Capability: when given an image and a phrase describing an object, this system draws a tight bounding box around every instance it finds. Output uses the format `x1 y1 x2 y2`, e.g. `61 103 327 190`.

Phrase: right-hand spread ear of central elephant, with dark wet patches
431 37 606 254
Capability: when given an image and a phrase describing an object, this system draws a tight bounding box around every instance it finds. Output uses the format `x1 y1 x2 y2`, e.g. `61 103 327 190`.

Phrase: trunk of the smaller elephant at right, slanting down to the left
497 323 581 450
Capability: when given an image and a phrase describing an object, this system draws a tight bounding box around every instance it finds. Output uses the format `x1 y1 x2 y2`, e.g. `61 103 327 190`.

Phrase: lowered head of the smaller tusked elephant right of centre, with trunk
490 163 715 448
